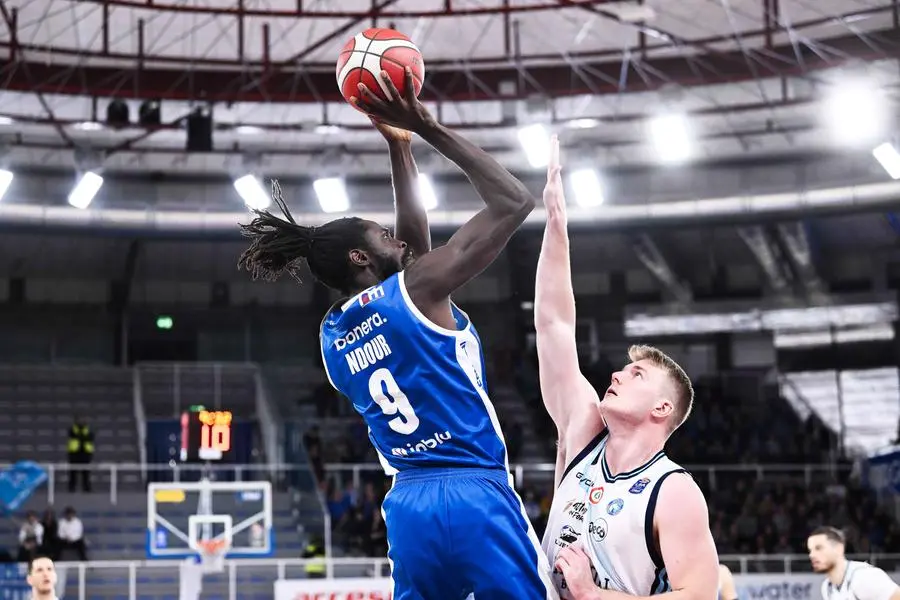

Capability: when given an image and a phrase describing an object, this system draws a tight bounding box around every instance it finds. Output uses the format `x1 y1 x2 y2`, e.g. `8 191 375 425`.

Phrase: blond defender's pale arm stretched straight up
534 147 604 479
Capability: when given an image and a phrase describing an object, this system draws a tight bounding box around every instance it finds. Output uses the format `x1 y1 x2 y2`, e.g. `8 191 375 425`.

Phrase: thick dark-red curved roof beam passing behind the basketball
0 31 900 102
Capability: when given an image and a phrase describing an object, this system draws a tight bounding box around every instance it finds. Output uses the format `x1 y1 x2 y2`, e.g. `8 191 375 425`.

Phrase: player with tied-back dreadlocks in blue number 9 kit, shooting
239 71 557 600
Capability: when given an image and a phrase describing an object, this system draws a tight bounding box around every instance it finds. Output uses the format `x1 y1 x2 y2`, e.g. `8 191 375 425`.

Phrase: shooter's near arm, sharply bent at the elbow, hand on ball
355 69 535 324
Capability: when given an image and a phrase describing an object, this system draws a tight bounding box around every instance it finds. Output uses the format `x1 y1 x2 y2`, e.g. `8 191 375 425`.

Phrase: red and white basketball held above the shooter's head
335 27 425 108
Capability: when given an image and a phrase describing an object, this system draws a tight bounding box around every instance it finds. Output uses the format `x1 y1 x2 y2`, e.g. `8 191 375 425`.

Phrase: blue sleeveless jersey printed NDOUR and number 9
319 272 507 474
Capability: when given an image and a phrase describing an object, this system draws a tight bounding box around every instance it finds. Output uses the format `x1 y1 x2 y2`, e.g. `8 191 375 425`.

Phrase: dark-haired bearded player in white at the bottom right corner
806 526 900 600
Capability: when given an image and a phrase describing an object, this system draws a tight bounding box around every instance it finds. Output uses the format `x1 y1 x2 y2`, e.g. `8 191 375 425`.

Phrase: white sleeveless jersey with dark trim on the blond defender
542 431 686 599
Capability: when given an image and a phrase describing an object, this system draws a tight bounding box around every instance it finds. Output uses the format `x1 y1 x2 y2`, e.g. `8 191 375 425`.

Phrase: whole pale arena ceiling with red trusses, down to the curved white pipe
0 0 900 251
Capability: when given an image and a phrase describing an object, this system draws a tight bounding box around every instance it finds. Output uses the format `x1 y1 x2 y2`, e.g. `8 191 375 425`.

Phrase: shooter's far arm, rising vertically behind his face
372 119 431 258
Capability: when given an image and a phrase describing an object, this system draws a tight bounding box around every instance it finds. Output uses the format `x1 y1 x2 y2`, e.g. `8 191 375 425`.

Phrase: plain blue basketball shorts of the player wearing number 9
383 469 558 600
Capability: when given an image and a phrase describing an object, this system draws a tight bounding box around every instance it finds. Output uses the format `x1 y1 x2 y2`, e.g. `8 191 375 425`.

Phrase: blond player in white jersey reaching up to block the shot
535 143 719 600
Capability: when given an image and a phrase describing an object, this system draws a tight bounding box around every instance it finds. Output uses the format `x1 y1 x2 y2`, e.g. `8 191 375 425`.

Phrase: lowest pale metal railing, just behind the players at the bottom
8 554 900 600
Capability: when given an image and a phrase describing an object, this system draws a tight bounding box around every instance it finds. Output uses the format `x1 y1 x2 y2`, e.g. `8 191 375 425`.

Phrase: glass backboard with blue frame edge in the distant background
147 480 275 559
